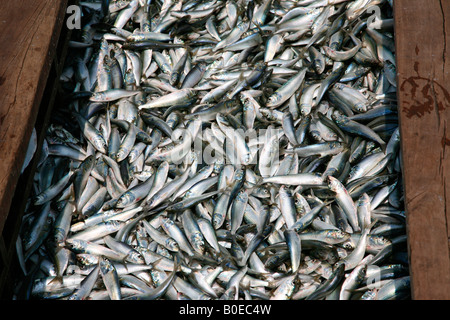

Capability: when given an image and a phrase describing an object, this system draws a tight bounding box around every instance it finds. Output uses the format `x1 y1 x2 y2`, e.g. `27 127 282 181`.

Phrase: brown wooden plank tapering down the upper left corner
0 0 67 234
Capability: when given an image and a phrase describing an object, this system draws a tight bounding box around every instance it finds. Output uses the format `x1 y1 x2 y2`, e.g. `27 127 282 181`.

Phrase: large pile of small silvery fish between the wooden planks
15 0 410 300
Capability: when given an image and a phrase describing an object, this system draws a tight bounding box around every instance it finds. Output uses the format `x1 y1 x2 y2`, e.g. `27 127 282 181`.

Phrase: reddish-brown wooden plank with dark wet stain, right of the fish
394 0 450 300
